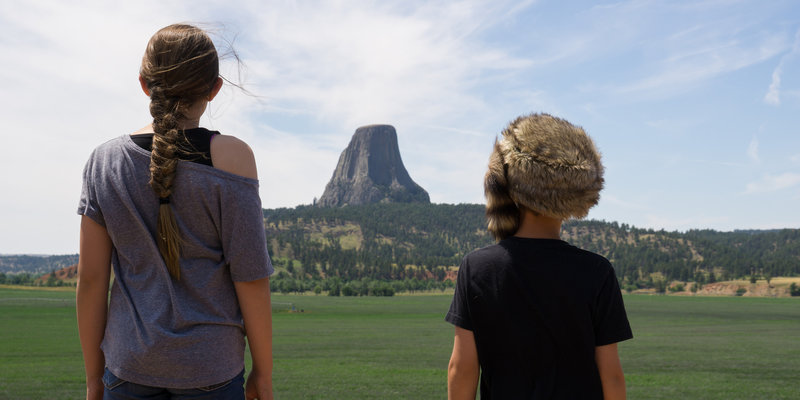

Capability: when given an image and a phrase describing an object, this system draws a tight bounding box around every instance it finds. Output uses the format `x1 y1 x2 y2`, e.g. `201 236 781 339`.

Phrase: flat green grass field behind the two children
0 287 800 399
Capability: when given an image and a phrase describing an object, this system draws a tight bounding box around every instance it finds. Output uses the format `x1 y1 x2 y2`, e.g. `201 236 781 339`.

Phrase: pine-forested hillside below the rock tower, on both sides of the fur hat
264 204 800 287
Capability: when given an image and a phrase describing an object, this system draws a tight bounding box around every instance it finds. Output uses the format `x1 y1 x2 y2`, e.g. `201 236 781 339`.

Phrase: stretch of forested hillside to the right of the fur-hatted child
563 221 800 286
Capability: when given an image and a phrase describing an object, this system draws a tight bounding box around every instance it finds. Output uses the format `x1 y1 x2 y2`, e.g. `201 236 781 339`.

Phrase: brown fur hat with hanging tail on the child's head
484 114 604 239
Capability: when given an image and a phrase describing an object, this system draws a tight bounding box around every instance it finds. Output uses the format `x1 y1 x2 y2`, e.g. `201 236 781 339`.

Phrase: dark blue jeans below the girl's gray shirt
103 368 244 400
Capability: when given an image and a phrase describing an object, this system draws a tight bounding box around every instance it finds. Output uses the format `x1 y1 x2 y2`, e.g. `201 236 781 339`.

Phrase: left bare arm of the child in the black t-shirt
447 327 480 400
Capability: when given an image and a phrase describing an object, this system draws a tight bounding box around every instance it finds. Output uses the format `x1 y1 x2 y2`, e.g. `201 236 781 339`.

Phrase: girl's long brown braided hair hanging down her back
139 24 219 279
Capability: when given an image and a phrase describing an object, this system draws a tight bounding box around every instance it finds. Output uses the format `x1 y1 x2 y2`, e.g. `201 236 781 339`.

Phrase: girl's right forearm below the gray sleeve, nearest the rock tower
234 278 272 400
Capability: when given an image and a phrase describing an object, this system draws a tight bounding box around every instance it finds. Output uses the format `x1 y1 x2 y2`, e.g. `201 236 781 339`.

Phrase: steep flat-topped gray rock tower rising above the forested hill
318 125 430 207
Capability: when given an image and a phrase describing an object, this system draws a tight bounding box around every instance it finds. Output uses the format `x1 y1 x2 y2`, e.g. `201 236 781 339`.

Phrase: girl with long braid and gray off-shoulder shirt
77 25 273 399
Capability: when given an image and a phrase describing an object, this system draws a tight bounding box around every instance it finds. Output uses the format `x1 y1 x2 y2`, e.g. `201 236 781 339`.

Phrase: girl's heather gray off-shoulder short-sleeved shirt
78 135 273 388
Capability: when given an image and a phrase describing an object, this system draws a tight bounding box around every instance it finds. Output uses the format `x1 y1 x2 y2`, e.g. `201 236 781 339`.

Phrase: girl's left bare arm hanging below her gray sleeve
75 216 111 399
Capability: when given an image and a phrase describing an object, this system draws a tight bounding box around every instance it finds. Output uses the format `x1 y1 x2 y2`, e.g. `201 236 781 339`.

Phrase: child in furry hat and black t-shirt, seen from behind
446 114 632 400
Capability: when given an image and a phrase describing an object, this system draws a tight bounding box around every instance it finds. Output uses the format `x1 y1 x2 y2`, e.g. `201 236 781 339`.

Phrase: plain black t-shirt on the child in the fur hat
445 237 633 400
